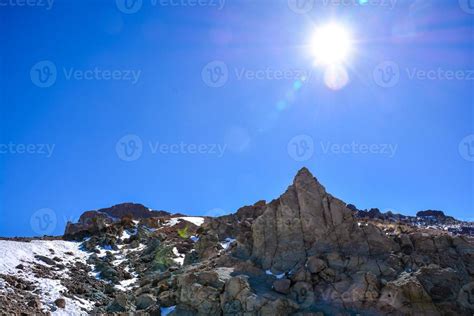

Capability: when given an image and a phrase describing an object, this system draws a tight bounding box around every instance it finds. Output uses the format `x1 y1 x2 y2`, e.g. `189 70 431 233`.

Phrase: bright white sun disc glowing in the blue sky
310 23 352 66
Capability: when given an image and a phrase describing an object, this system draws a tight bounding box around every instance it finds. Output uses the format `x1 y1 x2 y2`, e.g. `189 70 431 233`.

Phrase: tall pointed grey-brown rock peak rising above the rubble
252 168 395 272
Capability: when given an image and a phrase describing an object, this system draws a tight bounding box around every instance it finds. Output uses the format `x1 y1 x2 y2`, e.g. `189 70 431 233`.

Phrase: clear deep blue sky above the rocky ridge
0 0 474 236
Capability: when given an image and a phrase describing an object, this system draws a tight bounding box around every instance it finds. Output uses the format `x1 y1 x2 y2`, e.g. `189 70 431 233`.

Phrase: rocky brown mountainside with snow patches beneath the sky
0 168 474 316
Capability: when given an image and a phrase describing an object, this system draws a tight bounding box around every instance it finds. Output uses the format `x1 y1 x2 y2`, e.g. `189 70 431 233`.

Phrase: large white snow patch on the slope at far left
0 240 93 315
